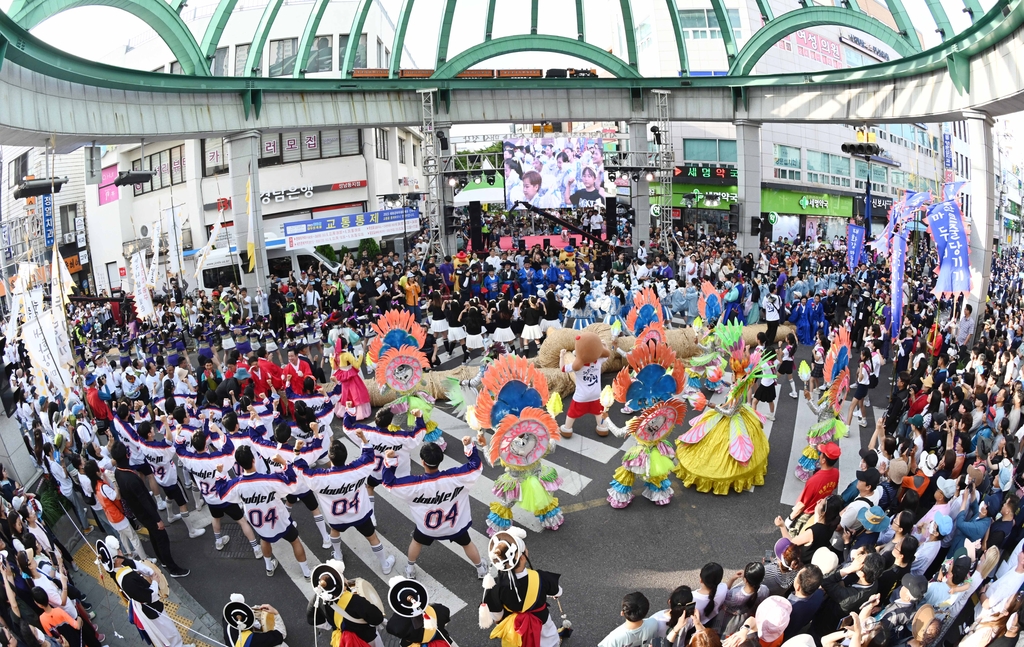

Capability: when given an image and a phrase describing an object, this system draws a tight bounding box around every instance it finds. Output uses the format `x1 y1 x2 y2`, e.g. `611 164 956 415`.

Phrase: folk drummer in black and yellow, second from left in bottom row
306 559 384 647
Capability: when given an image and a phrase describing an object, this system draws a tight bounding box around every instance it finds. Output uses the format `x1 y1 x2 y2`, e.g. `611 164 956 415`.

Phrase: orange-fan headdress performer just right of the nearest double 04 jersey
454 355 564 534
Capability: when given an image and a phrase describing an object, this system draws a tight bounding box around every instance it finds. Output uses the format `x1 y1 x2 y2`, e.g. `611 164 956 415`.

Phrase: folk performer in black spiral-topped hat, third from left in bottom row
387 577 453 647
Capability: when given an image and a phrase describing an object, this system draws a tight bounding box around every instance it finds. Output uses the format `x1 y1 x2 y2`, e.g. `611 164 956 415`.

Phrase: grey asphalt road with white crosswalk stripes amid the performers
157 347 887 647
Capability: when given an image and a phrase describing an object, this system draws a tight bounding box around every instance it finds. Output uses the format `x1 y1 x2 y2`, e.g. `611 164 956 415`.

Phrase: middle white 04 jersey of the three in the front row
295 444 375 526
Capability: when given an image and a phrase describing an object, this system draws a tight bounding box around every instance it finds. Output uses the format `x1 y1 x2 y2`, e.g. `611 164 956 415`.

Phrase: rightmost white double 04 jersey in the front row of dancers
383 444 483 537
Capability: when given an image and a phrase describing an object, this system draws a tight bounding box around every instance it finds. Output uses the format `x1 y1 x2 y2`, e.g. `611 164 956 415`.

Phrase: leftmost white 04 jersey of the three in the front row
217 468 299 540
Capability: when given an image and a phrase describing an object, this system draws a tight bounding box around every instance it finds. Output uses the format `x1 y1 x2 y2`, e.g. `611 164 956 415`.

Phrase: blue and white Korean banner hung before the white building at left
284 209 420 250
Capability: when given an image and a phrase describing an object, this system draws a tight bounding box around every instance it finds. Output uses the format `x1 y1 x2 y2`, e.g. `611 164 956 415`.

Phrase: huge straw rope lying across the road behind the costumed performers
364 324 796 406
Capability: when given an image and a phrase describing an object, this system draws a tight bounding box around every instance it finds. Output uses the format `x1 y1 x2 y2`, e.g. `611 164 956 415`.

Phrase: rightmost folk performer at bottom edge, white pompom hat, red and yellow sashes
479 526 562 647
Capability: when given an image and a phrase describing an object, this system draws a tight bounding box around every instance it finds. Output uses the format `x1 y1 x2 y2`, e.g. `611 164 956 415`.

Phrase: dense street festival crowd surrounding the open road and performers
6 185 1024 647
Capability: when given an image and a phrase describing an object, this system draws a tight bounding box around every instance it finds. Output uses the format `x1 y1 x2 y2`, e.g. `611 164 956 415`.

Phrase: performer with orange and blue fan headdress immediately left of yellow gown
602 343 703 509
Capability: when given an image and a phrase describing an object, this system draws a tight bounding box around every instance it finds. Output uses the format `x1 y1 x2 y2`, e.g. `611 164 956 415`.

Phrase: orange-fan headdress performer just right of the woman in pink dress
370 310 447 450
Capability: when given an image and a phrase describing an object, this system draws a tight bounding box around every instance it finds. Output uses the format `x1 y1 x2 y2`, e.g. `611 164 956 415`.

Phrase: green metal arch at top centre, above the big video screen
431 34 641 79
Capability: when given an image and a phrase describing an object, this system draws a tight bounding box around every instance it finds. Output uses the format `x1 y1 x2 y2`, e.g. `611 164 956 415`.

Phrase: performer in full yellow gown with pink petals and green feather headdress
676 324 773 494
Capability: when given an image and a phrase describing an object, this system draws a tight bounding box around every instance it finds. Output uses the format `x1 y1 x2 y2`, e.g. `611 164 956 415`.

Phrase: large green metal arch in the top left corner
10 0 210 77
